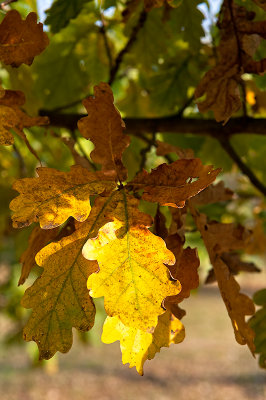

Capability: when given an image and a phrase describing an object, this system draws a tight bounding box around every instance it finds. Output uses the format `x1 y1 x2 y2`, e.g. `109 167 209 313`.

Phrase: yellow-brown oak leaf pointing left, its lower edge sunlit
10 166 116 229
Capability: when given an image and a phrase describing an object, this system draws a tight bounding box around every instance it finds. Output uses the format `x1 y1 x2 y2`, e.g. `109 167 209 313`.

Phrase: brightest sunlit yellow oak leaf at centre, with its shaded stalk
83 191 181 332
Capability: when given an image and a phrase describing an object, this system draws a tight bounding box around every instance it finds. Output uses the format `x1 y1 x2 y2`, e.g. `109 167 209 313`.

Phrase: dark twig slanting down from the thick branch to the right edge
218 138 266 196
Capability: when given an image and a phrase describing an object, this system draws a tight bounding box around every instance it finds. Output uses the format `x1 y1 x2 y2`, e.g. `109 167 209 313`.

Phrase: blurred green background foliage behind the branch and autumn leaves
0 0 266 368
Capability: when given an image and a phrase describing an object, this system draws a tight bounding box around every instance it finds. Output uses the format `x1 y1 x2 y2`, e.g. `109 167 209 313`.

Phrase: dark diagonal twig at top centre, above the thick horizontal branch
108 10 147 86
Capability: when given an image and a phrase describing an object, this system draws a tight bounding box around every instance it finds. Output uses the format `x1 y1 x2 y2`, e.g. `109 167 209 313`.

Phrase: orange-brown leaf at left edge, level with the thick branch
0 90 49 147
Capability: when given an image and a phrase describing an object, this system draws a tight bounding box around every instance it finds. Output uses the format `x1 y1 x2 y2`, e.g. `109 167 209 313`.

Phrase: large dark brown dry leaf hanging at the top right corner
195 0 266 123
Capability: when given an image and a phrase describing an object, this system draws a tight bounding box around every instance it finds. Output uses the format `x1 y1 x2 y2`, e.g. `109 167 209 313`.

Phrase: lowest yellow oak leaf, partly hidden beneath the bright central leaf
102 311 185 375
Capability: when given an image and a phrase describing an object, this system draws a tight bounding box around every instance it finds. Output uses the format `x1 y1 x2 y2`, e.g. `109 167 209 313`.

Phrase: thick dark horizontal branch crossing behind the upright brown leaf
41 110 266 139
